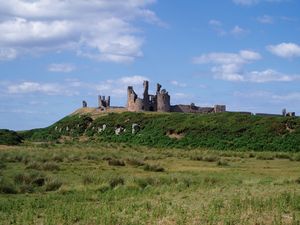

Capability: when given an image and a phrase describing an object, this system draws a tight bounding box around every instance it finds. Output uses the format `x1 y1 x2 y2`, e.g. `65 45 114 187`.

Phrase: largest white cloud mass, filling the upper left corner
0 0 164 62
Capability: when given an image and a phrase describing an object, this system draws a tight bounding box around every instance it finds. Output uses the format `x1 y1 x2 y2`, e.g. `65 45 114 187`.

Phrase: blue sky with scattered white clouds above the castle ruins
0 0 300 130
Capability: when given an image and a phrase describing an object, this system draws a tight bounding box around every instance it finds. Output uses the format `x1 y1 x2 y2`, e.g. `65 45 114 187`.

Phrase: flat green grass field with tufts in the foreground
0 143 300 225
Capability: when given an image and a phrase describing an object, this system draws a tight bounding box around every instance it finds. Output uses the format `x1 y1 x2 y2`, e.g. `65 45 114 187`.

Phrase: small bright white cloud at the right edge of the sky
267 43 300 58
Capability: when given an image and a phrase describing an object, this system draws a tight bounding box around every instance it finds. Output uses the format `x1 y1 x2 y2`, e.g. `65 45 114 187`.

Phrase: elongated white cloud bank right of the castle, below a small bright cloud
193 50 300 83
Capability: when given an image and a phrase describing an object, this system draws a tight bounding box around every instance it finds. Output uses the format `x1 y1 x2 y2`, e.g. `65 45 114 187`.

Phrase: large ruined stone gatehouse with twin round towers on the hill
127 81 171 112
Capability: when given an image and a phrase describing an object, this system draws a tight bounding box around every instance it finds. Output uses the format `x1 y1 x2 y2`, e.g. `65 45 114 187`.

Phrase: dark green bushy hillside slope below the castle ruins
22 112 300 152
